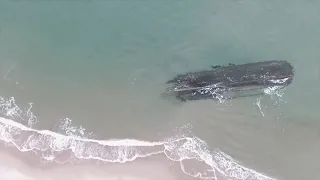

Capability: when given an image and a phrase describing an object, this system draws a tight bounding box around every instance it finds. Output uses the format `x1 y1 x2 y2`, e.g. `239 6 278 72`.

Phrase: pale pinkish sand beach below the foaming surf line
0 145 185 180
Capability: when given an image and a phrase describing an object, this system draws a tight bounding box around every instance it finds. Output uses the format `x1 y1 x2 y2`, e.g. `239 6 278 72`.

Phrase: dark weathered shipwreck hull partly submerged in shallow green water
166 60 294 101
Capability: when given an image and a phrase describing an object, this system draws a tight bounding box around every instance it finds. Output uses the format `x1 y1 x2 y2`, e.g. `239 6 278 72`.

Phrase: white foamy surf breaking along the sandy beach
0 98 273 180
